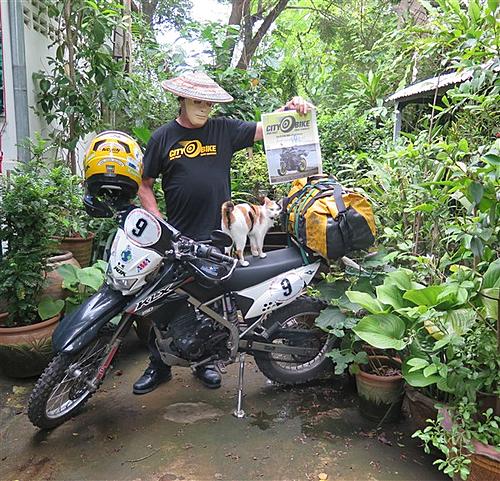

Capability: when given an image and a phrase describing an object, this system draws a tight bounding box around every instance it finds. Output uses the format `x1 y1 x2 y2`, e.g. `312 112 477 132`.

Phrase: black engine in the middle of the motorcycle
168 312 229 361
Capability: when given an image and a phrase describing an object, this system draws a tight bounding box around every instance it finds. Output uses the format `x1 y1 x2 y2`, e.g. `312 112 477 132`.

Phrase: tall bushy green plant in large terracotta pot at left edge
0 158 63 377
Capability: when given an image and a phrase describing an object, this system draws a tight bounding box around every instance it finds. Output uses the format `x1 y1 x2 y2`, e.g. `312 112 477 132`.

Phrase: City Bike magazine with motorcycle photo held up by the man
262 110 322 184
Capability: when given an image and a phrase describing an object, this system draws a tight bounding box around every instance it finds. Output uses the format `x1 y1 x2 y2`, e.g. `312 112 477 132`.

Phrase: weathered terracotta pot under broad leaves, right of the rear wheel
356 356 404 423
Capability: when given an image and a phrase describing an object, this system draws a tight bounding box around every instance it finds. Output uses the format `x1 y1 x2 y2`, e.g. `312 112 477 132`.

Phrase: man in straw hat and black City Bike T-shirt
134 72 311 394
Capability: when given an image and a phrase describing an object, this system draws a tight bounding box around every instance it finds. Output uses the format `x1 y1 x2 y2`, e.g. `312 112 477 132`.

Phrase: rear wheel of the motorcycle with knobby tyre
255 296 339 385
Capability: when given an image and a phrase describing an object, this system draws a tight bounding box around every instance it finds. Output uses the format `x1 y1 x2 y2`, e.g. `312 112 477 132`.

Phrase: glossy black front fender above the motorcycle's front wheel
52 285 130 353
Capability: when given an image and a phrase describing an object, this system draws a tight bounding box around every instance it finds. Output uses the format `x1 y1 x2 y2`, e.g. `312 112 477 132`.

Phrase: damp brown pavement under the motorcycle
0 335 449 481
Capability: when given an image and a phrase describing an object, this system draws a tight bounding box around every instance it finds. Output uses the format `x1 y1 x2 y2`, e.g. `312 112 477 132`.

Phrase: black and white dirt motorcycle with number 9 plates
28 206 338 429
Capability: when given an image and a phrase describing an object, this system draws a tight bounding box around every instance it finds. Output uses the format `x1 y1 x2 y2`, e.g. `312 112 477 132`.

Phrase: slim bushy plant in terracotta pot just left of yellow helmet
48 161 95 267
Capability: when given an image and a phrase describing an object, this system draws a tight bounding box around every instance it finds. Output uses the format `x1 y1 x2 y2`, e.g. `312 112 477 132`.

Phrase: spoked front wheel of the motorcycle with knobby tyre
28 334 110 429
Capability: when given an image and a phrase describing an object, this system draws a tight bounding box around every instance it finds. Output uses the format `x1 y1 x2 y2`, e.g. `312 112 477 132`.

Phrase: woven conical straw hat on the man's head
161 72 234 103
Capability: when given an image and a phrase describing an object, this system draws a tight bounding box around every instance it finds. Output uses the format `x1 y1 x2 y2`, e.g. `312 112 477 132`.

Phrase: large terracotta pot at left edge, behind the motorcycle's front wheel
0 313 60 378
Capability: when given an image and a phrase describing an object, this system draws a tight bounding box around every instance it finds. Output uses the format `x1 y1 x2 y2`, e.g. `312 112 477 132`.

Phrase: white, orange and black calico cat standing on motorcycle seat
221 197 281 266
